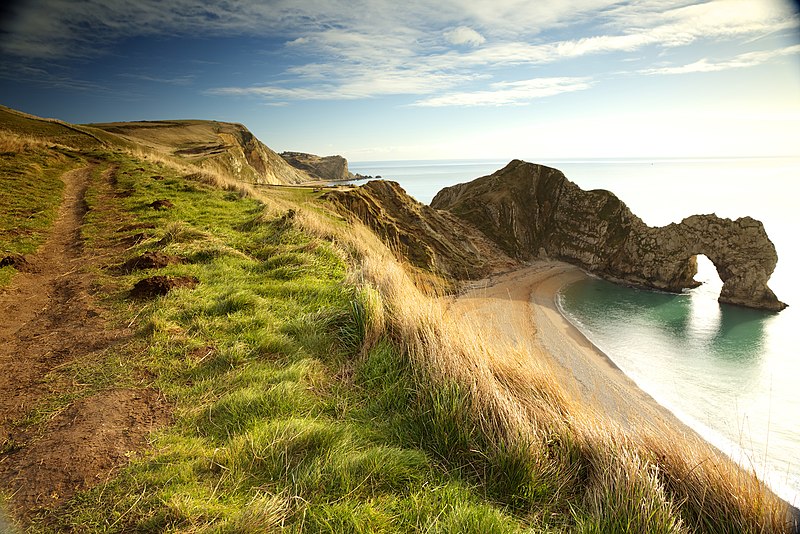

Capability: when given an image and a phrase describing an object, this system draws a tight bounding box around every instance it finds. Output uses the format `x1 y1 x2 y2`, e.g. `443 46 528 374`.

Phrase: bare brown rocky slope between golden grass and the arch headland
324 180 516 280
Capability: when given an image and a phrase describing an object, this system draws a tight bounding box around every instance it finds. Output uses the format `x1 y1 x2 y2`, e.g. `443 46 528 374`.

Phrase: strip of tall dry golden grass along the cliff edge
108 137 787 533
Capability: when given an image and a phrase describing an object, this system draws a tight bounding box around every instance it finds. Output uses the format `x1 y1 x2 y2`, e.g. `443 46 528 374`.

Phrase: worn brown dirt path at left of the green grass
0 165 165 517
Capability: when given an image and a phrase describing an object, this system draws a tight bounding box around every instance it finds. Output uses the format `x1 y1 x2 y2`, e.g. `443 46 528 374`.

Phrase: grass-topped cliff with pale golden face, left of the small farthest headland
91 120 312 184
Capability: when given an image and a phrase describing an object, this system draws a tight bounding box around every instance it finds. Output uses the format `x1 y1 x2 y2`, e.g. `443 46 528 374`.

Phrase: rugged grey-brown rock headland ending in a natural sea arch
431 160 786 311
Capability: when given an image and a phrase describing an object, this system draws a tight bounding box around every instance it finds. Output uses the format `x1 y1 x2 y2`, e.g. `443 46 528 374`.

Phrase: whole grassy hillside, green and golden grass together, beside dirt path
0 111 786 533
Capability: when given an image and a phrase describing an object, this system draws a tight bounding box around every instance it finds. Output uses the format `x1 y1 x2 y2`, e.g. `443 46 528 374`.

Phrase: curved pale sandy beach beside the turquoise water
456 260 800 532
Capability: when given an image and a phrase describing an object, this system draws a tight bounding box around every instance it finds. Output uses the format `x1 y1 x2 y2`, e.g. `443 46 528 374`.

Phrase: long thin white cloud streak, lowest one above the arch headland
414 77 592 107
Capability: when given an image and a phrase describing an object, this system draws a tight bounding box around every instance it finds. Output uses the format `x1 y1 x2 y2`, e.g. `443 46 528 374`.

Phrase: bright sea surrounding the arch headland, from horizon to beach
350 157 800 506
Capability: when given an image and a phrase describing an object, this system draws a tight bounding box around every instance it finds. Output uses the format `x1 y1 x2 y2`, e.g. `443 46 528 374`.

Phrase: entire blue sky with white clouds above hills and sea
0 0 800 162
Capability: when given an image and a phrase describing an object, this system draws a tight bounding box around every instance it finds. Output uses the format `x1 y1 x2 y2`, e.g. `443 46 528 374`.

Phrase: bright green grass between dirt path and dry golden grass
17 153 544 532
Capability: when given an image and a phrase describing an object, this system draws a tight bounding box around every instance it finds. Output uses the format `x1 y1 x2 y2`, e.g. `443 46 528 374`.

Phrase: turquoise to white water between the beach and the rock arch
559 268 800 501
